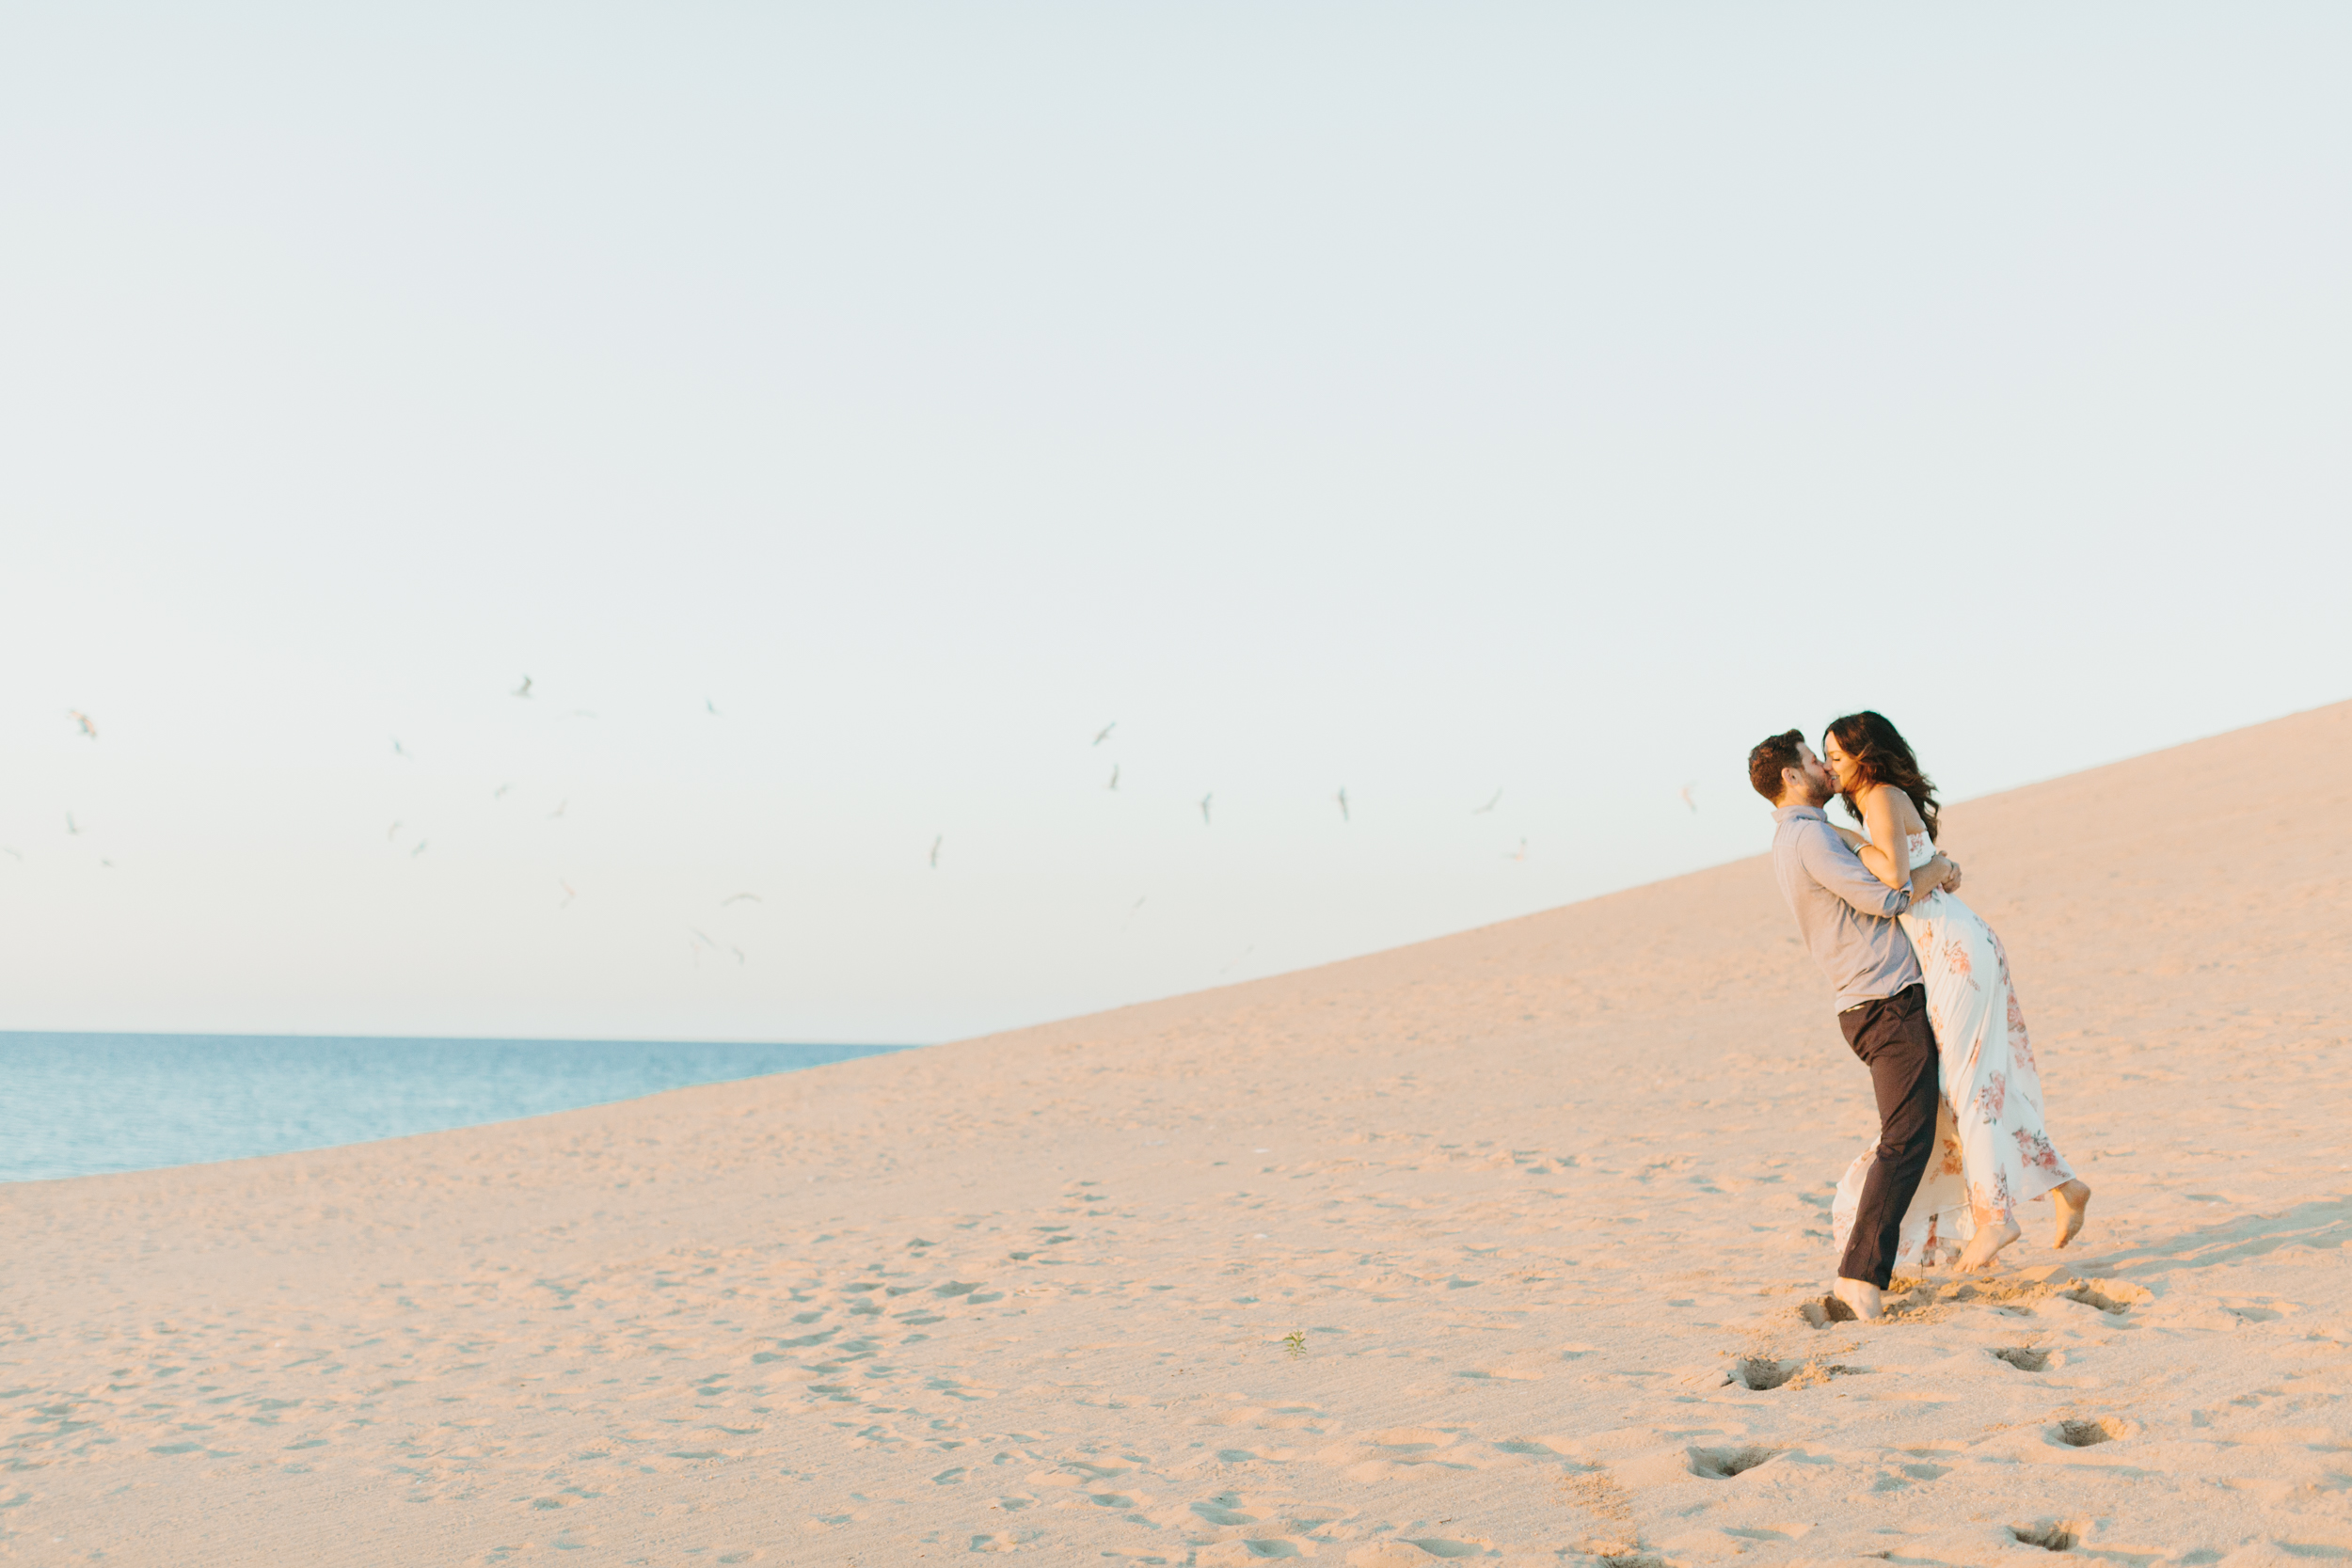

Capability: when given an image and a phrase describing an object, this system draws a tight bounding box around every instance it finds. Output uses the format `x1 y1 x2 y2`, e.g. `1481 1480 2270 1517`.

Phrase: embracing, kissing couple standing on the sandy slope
1748 712 2091 1319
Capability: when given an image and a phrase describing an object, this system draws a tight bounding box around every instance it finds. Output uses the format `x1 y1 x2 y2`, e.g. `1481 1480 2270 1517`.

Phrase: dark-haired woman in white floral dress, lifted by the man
1820 712 2091 1270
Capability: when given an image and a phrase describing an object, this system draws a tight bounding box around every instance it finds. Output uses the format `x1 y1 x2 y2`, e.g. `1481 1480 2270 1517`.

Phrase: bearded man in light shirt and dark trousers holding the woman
1748 729 1960 1319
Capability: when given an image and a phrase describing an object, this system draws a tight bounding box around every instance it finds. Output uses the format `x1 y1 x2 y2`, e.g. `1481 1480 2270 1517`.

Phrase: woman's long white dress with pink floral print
1830 832 2074 1267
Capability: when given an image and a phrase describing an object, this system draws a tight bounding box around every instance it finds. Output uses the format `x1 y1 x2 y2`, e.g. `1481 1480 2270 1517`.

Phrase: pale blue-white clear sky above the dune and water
0 5 2352 1041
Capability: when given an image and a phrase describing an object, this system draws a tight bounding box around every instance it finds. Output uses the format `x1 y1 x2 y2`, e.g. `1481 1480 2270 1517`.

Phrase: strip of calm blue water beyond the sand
0 1032 908 1182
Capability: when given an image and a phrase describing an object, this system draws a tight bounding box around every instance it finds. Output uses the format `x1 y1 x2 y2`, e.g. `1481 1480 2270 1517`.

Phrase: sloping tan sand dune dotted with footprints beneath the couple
0 705 2352 1568
